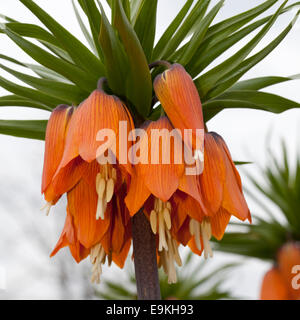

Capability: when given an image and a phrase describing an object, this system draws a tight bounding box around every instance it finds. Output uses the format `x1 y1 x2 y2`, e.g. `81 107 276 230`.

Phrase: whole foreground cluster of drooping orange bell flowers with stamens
42 64 251 283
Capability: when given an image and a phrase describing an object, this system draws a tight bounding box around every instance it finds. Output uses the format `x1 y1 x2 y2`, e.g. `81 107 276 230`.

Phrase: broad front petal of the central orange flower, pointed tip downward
136 117 184 201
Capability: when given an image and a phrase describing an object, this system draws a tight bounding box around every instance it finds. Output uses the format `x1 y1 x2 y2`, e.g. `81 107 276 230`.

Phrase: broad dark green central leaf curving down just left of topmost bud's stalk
113 0 152 117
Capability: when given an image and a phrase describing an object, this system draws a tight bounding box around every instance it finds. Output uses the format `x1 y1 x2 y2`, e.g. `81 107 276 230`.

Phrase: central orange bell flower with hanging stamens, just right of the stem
125 117 204 283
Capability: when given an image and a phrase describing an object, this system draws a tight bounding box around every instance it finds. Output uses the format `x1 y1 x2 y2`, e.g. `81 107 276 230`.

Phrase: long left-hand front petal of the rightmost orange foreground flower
199 133 225 216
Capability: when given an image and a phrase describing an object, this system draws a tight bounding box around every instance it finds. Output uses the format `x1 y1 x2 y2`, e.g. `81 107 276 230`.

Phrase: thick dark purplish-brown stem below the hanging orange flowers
131 210 161 300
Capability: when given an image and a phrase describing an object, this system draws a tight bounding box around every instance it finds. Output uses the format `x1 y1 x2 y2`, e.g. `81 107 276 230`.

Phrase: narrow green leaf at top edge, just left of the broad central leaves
78 0 103 60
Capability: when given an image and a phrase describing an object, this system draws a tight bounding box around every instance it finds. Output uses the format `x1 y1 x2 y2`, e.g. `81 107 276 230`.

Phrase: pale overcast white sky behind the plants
0 0 300 299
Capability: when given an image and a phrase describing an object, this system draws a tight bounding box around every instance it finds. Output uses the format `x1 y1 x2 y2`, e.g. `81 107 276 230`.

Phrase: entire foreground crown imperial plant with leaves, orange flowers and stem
0 0 299 299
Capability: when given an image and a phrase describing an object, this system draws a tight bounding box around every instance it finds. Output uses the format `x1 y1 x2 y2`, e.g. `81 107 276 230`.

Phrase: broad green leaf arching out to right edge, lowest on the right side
203 90 300 121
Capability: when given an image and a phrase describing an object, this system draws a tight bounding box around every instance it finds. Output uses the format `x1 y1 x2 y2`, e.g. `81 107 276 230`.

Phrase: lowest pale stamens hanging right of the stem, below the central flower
159 234 182 284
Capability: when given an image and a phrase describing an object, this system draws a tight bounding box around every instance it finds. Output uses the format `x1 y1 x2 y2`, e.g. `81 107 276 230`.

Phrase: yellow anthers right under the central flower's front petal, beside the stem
154 198 172 251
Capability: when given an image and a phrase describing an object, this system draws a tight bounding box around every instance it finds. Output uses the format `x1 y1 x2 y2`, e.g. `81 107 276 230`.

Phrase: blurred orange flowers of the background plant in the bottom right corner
260 242 300 300
